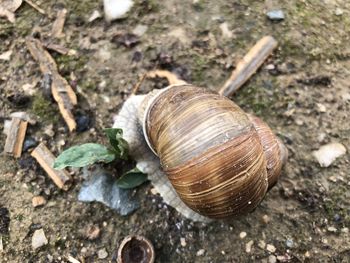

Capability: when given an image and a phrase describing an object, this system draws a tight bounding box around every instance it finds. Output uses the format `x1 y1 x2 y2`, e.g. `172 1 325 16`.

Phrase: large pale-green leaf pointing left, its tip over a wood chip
53 143 116 169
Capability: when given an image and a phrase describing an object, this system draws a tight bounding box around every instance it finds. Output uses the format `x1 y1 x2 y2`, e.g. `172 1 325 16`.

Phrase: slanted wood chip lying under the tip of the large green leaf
32 143 72 191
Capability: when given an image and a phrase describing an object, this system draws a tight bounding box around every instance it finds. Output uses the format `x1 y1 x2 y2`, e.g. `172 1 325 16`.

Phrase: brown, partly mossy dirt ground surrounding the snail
0 0 350 263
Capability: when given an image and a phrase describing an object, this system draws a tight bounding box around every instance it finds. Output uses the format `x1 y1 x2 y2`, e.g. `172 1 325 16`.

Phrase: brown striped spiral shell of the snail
139 84 287 219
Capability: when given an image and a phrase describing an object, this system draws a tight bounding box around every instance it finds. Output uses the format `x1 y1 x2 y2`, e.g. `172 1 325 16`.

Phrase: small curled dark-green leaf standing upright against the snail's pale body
104 128 129 160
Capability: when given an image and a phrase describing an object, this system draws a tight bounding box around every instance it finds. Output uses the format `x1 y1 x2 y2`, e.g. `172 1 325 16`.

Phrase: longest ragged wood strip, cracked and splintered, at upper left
26 38 77 131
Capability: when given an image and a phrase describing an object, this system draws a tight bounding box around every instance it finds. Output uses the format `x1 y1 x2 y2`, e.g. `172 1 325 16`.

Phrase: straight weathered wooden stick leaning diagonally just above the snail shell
219 36 277 97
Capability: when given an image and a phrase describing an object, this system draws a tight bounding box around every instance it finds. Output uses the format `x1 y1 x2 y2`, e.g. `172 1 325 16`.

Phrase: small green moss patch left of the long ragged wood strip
31 94 60 123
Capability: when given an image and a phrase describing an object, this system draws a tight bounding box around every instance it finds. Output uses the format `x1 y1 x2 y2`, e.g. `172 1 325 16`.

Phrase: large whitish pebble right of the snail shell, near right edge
312 142 346 167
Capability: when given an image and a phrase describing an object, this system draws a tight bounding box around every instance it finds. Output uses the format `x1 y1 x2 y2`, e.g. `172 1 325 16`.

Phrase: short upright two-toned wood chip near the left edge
4 118 28 158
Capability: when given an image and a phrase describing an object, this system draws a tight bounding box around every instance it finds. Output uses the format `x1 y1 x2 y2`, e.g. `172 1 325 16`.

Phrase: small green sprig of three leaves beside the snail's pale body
53 128 147 189
